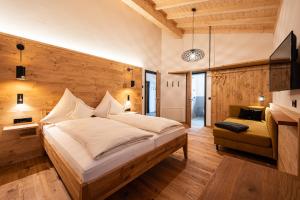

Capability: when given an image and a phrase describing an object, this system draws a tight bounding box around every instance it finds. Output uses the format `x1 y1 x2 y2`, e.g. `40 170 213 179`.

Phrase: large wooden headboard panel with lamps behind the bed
0 34 142 126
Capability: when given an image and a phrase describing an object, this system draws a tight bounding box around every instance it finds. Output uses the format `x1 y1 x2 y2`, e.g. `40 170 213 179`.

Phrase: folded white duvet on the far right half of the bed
108 114 182 133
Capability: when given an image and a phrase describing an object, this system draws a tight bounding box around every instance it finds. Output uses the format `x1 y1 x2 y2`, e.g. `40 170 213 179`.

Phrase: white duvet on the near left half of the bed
55 117 153 160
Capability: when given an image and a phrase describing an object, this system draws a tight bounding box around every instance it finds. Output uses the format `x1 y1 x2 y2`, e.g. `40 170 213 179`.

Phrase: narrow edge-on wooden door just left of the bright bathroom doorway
185 72 192 127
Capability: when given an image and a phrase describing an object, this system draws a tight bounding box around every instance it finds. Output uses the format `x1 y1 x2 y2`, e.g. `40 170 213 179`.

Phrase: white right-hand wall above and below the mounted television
273 0 300 112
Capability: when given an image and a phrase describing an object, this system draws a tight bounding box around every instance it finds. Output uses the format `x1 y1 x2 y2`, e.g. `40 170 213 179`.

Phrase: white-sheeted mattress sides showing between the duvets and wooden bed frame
43 125 185 182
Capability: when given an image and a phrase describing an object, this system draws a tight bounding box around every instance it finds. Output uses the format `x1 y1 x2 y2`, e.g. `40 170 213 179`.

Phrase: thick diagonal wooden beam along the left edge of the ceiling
122 0 184 38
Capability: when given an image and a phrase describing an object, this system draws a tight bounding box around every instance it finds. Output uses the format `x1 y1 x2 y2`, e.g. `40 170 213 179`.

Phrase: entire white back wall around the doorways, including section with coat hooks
161 31 273 125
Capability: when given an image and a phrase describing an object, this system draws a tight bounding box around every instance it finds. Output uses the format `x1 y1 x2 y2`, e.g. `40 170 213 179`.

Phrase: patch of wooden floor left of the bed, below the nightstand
0 156 70 200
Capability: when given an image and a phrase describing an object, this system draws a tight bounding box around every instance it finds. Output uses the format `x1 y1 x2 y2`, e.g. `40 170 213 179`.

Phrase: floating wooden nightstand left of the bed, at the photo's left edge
0 123 44 167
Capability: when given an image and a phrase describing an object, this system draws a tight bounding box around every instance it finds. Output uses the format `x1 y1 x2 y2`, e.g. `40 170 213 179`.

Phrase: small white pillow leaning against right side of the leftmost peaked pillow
69 98 95 119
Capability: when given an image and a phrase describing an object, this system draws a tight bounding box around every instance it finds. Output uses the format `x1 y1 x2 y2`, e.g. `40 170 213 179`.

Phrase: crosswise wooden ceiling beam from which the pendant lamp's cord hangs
167 5 278 20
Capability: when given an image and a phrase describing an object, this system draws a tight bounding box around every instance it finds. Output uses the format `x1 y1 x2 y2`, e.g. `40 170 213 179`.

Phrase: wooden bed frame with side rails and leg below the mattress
42 133 188 200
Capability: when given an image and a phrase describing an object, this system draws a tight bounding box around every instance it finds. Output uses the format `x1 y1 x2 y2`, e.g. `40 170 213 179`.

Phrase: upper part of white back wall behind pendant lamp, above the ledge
161 31 273 71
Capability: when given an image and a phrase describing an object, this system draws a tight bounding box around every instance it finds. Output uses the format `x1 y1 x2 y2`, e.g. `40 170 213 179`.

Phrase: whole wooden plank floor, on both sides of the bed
0 128 274 200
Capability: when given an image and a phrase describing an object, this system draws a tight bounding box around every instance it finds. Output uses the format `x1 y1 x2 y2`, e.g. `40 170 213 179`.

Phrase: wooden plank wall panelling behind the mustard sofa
211 65 272 124
